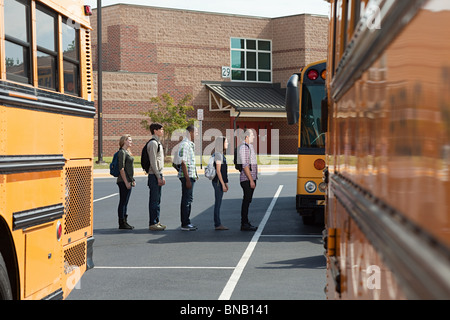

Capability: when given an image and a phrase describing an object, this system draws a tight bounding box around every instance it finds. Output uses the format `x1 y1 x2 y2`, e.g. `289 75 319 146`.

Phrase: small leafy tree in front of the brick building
141 93 195 154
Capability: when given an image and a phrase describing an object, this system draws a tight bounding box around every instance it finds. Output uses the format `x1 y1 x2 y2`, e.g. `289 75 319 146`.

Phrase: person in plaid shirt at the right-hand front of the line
239 129 258 231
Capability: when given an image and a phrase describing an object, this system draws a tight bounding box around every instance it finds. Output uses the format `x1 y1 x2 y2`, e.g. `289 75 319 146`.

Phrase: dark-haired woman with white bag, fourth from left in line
212 136 228 230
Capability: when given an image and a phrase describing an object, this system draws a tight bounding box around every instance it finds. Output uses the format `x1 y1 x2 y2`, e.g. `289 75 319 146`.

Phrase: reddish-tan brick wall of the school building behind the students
91 5 328 156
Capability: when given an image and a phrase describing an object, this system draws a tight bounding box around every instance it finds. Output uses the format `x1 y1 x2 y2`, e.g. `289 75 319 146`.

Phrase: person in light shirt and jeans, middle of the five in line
178 125 198 231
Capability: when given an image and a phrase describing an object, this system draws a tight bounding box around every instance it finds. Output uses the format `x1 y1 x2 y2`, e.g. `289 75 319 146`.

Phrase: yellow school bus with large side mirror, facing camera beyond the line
286 60 326 224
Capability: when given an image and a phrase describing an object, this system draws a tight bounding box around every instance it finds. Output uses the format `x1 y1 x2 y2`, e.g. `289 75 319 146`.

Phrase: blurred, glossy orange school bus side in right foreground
324 0 450 299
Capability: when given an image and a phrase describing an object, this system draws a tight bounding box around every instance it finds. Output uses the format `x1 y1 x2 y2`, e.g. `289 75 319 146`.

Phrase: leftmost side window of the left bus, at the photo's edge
4 0 31 84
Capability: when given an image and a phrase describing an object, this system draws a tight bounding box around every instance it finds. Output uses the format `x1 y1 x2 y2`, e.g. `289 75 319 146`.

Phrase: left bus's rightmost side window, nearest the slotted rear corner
62 21 80 95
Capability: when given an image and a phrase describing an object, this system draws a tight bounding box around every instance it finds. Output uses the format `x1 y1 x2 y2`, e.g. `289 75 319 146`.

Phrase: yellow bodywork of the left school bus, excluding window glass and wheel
0 0 95 300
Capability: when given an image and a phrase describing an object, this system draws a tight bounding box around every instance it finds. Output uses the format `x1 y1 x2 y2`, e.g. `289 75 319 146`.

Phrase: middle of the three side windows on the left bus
36 8 58 90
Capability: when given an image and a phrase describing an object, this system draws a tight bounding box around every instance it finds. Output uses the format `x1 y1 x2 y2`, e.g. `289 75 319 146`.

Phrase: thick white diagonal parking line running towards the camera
219 185 283 300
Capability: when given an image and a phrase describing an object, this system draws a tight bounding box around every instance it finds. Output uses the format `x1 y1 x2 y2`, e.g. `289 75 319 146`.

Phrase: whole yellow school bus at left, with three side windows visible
0 0 95 300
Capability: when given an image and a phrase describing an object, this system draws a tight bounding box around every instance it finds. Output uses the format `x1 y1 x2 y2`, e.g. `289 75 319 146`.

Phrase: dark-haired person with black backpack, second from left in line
147 123 166 231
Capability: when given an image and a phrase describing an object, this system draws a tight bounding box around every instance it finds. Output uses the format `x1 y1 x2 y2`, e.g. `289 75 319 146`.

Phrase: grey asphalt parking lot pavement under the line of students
68 166 326 304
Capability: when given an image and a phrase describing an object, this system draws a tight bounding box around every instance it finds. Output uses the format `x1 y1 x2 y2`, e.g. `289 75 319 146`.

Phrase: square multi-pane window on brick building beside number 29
231 38 272 82
